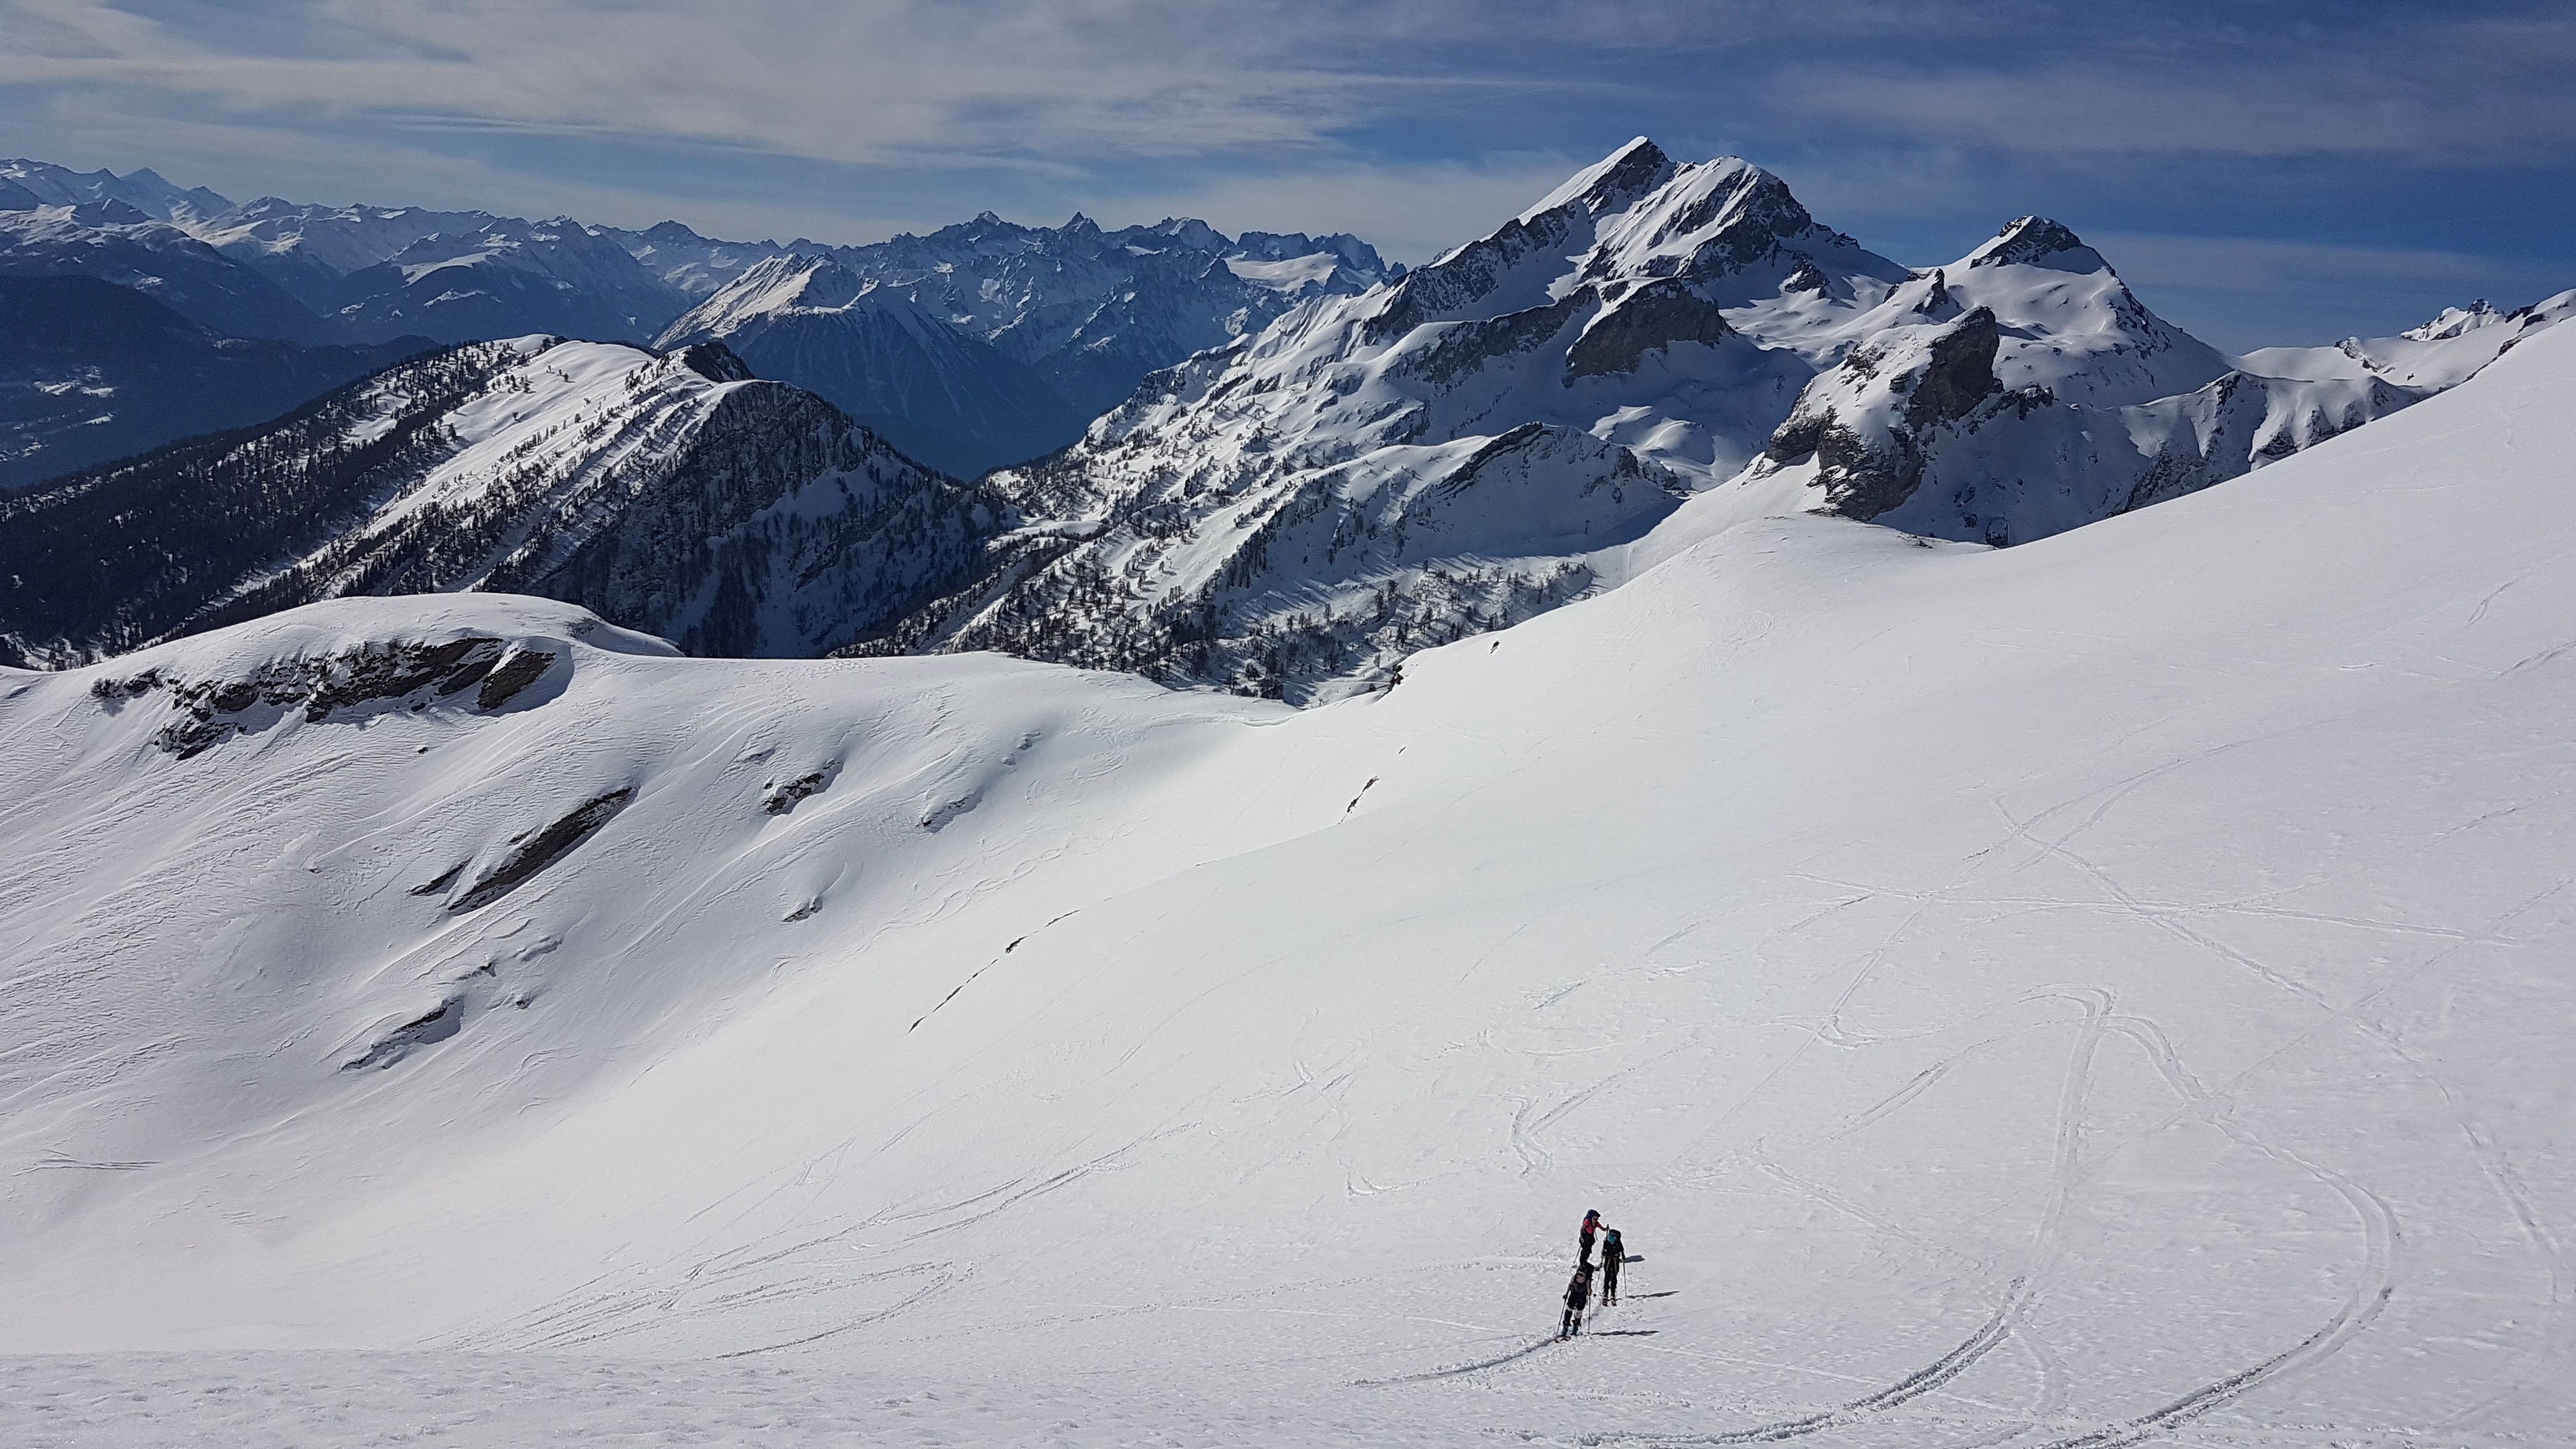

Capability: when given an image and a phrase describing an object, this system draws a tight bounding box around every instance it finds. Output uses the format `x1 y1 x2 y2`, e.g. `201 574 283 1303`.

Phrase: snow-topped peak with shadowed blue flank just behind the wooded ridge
659 256 1082 477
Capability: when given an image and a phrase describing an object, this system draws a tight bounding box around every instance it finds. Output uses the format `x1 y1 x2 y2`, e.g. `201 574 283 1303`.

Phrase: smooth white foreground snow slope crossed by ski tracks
0 330 2576 1449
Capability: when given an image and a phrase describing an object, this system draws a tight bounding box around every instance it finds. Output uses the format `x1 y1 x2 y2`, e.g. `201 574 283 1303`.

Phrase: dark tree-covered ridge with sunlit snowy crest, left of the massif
0 338 994 663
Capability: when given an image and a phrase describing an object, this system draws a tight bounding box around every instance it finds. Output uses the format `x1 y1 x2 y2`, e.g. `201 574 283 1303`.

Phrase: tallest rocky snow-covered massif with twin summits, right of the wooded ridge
868 139 2576 702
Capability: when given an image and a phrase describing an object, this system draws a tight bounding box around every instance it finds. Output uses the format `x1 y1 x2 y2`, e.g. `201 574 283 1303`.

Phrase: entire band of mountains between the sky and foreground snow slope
0 139 2576 704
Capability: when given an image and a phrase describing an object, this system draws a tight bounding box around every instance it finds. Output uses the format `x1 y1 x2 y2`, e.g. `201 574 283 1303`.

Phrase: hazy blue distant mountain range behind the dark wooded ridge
0 160 1401 475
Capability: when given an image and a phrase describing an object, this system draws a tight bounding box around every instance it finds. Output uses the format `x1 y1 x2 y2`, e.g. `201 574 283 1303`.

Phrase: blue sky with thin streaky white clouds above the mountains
0 0 2576 348
